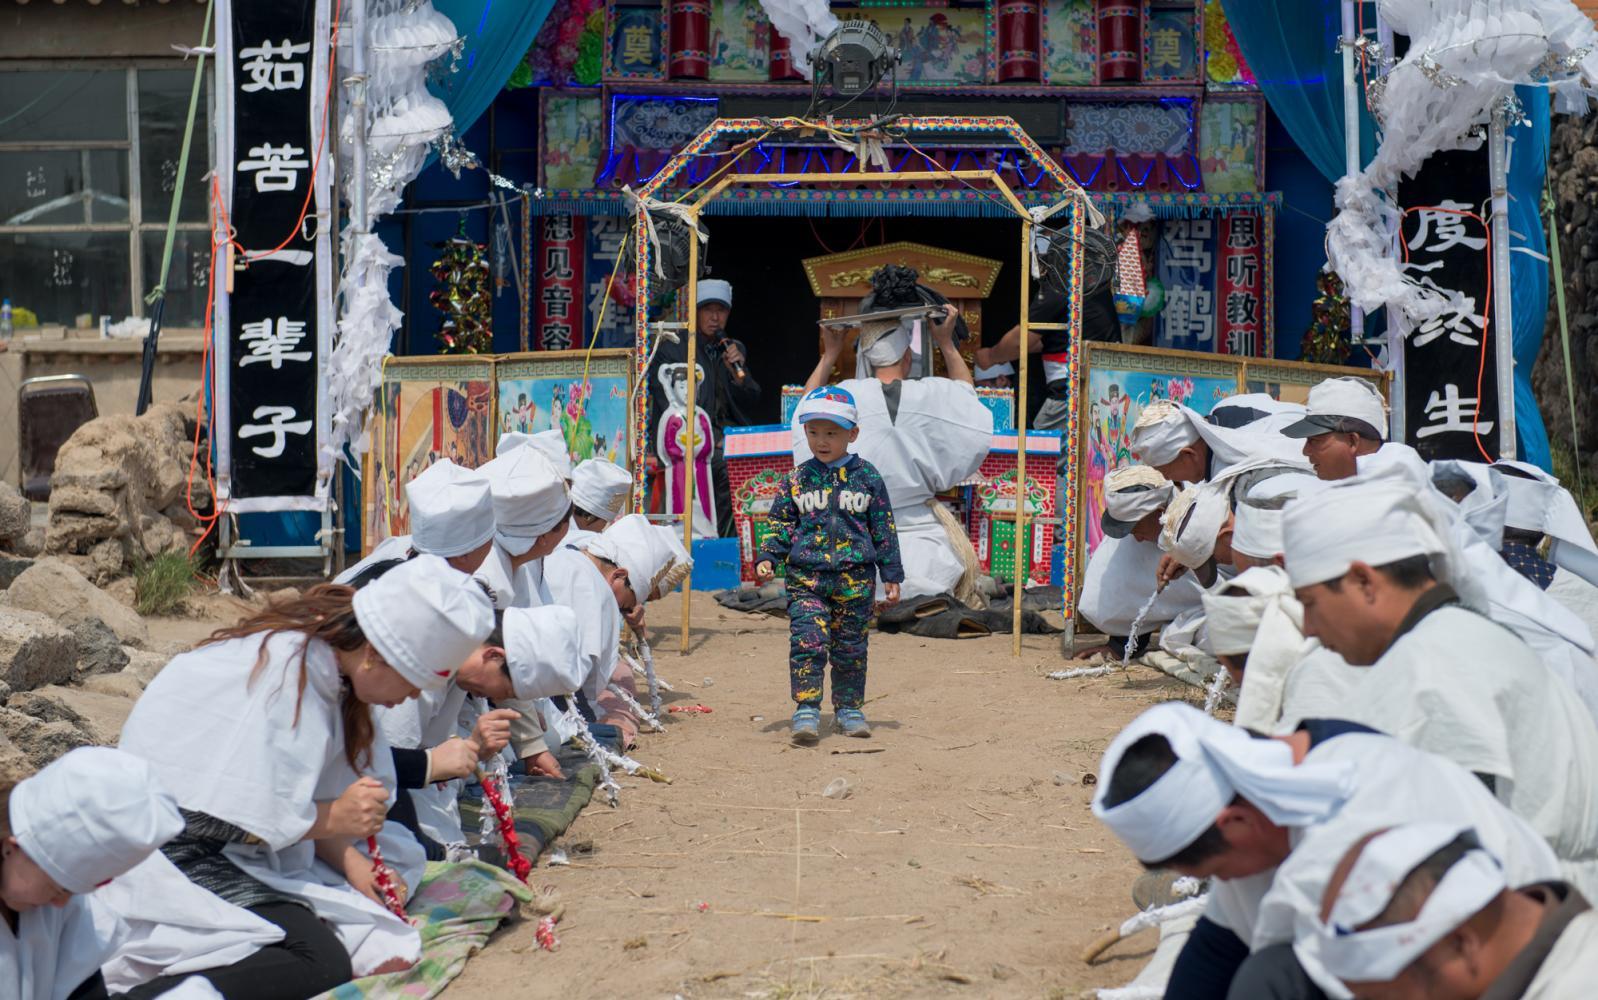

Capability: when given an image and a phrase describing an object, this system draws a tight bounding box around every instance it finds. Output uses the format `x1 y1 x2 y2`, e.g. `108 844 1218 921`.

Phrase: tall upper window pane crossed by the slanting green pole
139 69 211 222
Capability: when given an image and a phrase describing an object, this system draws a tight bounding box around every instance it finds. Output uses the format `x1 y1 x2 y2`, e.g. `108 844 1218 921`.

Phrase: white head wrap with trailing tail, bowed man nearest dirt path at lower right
1093 701 1355 864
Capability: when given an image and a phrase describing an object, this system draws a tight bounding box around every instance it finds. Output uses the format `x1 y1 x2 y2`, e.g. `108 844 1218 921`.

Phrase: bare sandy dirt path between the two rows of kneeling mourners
446 594 1195 1000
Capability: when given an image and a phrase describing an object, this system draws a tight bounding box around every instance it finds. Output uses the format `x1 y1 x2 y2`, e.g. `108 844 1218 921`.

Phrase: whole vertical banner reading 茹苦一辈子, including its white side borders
216 0 332 511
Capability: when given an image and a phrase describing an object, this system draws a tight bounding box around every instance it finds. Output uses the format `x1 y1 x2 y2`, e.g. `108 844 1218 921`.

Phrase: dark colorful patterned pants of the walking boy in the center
788 565 876 709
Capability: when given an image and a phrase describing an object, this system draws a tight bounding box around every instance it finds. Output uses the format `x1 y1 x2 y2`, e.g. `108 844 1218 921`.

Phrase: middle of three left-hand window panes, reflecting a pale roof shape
0 149 128 225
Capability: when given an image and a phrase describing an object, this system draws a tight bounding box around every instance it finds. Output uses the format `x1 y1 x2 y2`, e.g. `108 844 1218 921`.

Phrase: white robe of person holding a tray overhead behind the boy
793 379 994 601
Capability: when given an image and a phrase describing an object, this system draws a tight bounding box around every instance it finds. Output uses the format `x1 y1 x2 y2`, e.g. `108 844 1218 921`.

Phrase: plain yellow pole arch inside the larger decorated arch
642 171 1079 657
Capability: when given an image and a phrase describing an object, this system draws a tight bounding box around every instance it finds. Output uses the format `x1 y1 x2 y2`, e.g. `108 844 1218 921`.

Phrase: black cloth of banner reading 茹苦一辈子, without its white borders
229 0 319 498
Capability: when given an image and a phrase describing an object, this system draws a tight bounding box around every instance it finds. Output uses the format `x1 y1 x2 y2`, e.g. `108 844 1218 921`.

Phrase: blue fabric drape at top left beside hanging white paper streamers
431 0 555 136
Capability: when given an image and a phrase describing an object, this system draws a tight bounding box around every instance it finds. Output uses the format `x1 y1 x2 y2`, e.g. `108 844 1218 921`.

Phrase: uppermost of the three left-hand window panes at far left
0 69 128 142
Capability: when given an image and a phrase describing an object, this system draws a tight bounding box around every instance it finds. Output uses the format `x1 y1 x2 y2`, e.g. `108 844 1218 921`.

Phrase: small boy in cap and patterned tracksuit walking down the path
754 385 904 746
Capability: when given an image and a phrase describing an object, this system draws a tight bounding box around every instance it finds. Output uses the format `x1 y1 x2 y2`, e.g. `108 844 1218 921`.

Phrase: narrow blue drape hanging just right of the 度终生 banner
1509 86 1553 473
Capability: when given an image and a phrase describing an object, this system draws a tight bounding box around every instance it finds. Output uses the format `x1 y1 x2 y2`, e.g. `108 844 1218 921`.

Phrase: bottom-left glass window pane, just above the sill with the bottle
0 233 133 326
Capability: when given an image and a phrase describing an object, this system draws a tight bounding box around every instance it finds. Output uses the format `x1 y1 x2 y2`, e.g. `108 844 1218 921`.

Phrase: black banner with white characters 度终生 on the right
1398 147 1507 462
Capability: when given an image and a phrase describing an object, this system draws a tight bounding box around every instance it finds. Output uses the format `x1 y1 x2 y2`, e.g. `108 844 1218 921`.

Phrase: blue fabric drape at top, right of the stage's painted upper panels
1221 0 1376 182
